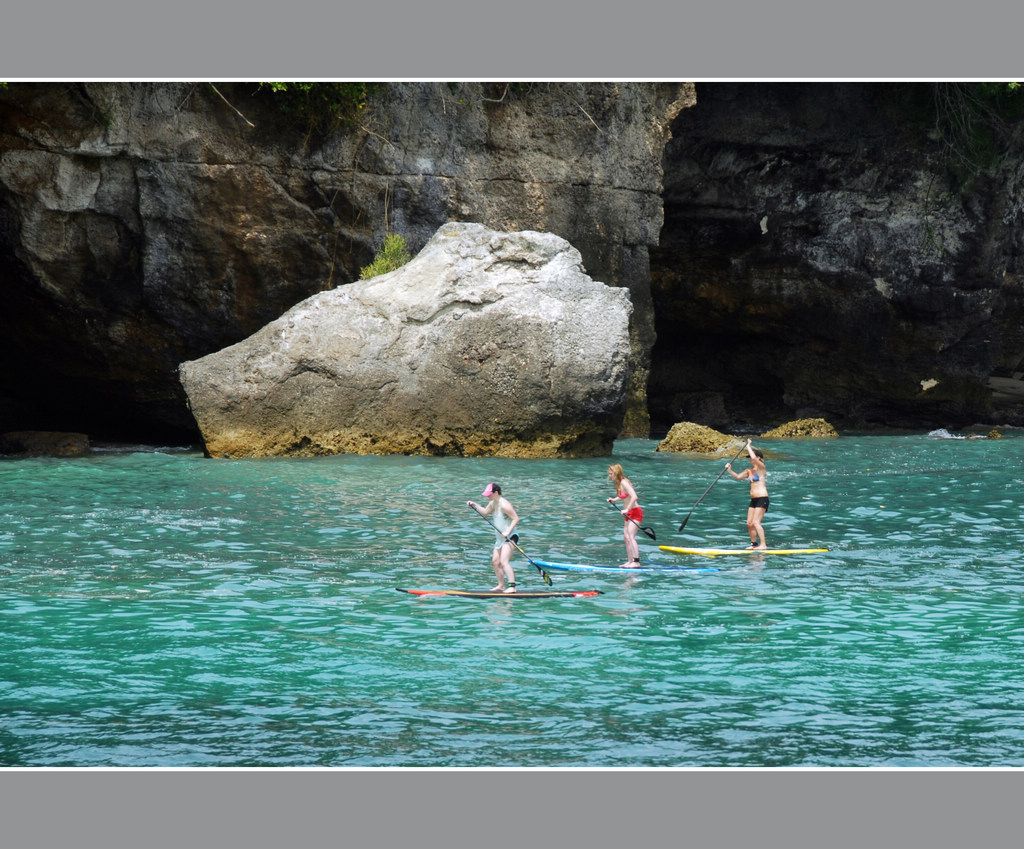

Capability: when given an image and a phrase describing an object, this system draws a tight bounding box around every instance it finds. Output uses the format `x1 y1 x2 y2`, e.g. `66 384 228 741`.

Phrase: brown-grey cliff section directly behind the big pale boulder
0 83 693 439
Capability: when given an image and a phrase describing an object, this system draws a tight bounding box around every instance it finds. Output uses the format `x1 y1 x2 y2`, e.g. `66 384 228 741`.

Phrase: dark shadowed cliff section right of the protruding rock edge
648 83 1024 428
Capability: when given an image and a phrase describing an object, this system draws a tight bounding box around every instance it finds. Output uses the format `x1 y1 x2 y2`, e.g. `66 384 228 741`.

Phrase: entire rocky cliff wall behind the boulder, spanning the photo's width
0 83 1024 439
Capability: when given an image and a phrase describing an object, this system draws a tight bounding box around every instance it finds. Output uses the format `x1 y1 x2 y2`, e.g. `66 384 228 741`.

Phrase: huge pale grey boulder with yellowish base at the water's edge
179 223 631 457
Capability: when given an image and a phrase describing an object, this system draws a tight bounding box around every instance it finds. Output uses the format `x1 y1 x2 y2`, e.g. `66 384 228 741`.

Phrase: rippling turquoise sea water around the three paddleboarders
0 431 1024 768
